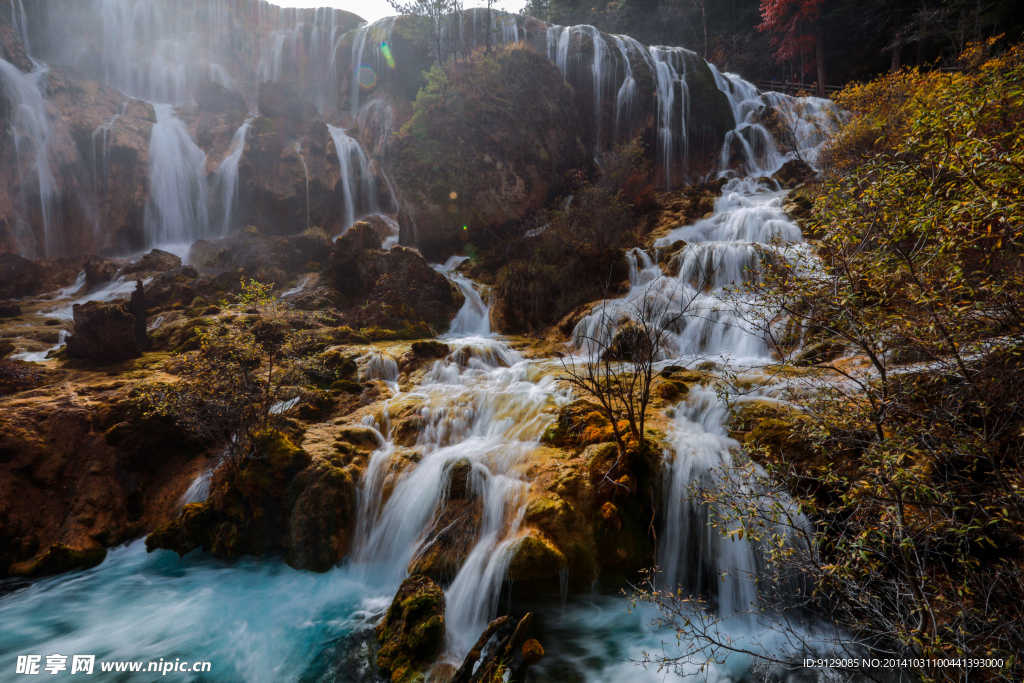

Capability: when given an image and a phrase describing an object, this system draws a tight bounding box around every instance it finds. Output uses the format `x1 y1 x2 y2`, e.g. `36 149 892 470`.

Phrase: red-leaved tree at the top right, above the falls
758 0 825 97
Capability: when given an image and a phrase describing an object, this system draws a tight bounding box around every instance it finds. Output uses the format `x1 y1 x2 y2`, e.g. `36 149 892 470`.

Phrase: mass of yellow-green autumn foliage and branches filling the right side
638 40 1024 681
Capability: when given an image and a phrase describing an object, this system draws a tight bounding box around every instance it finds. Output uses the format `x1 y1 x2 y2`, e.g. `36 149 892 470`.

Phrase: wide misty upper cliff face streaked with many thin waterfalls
0 0 753 258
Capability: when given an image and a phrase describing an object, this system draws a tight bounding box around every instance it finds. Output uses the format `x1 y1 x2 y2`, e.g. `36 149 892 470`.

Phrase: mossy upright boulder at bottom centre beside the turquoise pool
376 574 444 683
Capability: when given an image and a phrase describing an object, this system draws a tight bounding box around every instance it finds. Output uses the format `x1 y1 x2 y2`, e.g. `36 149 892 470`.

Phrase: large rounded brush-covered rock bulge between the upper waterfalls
391 43 585 261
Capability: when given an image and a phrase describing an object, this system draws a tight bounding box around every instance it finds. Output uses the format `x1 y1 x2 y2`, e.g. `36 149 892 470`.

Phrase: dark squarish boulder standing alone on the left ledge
68 301 144 361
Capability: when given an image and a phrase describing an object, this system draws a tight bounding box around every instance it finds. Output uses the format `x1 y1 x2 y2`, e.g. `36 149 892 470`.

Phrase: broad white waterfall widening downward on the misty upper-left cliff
145 104 210 247
